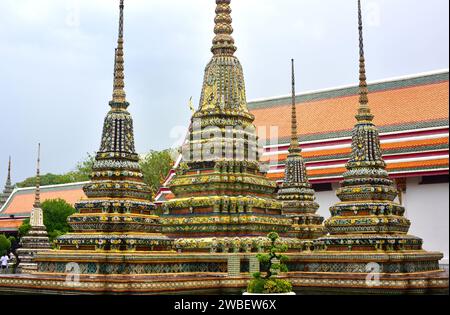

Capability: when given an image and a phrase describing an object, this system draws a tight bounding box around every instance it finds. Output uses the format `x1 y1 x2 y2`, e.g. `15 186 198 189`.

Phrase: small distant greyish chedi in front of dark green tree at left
17 145 51 273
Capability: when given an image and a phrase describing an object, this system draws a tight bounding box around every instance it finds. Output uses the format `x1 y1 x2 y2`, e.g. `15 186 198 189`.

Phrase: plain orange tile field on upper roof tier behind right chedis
251 81 449 138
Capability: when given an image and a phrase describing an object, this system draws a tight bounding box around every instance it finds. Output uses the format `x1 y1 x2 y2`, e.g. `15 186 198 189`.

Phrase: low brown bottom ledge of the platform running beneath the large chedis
0 271 448 295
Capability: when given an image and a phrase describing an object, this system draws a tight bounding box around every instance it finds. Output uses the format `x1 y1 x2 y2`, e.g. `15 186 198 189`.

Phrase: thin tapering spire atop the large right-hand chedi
356 0 373 121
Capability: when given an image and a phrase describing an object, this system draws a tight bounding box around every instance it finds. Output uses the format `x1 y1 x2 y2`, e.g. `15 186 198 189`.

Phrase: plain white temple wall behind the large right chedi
316 177 449 264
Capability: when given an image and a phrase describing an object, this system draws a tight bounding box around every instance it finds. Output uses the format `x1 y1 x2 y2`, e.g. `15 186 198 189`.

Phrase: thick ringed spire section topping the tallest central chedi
211 0 237 56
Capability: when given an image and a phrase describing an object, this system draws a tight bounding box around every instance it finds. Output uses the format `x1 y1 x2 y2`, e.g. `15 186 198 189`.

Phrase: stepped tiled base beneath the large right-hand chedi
288 250 449 294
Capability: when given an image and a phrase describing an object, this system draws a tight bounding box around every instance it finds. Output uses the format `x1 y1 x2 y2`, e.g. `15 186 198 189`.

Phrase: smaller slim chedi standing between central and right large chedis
278 60 324 245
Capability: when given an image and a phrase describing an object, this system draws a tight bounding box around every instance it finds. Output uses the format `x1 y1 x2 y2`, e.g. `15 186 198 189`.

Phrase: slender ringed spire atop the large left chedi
111 0 128 108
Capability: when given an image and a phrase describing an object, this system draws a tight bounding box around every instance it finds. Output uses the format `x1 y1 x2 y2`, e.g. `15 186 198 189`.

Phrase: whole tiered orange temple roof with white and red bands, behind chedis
156 70 449 203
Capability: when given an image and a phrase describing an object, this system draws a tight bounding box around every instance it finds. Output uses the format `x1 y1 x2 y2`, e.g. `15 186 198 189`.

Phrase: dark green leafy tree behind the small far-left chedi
19 199 76 241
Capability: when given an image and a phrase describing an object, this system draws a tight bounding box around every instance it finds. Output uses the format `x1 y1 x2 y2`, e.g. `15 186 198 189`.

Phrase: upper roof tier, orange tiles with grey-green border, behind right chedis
248 70 449 141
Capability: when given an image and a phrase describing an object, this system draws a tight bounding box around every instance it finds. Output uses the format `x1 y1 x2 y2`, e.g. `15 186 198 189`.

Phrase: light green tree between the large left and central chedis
140 150 175 197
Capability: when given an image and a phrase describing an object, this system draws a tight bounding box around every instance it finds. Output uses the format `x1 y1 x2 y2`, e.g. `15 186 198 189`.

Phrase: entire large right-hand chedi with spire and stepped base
292 0 448 293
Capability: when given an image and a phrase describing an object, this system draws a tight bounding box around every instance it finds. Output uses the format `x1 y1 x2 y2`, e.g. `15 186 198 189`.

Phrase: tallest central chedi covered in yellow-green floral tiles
163 0 290 251
